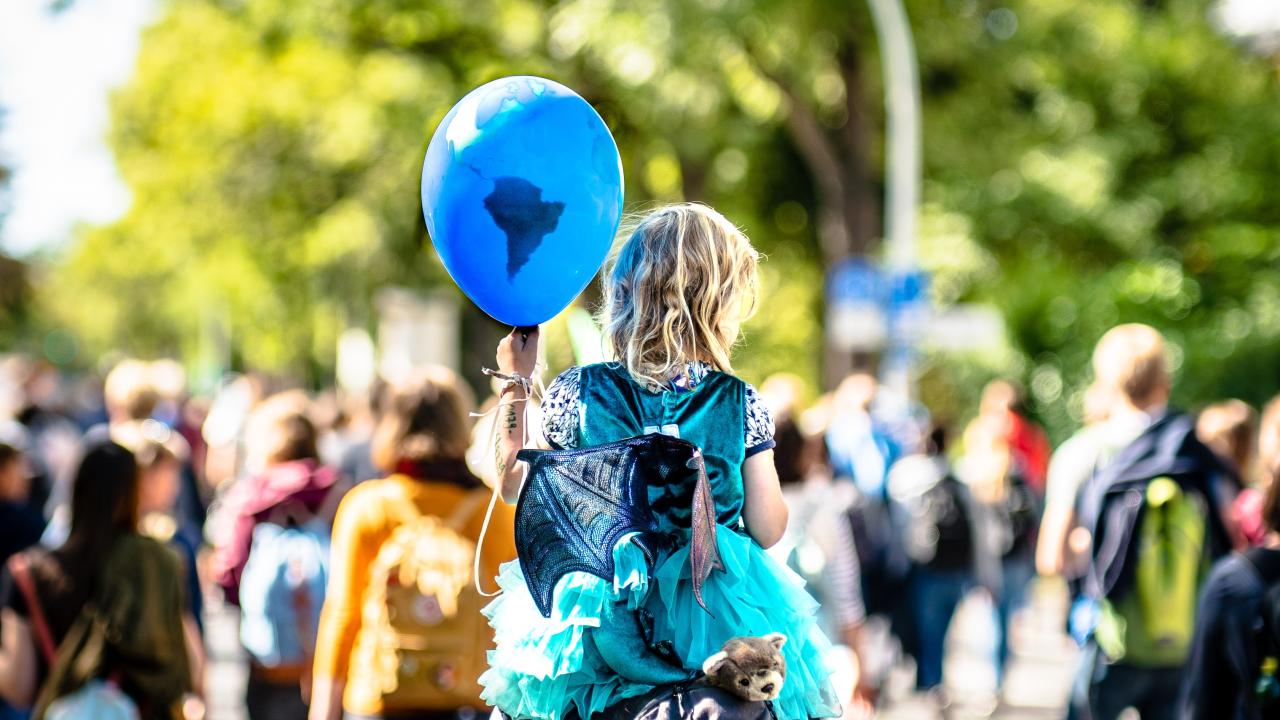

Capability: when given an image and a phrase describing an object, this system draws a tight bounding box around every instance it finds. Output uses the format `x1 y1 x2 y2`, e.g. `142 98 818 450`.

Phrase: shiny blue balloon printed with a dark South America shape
422 76 622 327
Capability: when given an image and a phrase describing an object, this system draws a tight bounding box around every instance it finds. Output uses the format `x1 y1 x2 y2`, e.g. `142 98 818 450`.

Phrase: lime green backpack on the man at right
1094 478 1208 667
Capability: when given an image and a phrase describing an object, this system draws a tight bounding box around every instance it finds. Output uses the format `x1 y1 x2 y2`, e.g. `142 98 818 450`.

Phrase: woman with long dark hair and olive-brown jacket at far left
0 441 192 720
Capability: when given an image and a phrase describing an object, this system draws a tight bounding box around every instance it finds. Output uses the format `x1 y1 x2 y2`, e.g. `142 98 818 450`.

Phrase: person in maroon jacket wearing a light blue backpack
211 391 346 720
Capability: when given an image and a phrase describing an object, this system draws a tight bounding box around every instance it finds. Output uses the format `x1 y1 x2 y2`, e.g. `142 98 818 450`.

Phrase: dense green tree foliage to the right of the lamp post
914 0 1280 436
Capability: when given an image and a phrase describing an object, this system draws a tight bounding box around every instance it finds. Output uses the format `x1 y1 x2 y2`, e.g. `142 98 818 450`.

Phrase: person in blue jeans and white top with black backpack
888 424 977 707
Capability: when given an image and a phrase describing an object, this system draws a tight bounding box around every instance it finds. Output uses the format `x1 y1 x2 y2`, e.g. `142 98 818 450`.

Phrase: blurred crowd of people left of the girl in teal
0 356 515 720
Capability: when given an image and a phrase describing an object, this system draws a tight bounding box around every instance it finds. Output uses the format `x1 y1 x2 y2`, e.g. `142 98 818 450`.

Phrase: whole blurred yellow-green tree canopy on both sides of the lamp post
41 0 1280 436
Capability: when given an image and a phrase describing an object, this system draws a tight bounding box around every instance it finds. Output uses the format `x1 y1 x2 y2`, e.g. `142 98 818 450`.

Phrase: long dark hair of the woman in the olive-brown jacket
58 441 138 589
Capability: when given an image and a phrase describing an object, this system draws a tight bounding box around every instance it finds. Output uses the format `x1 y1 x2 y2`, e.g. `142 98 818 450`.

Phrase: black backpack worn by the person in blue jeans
906 473 974 570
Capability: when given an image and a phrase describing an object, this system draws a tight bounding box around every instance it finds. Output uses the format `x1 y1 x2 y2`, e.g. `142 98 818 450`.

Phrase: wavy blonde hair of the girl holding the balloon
600 202 759 386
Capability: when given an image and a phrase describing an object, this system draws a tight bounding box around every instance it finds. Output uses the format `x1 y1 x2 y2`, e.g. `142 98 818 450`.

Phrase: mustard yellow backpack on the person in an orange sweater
352 491 493 710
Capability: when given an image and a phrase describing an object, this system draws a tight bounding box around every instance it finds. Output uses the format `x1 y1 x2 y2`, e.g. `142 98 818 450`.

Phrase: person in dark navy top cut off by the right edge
1181 409 1280 720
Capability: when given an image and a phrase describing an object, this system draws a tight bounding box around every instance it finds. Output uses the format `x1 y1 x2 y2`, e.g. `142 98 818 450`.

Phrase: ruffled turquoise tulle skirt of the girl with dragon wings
480 527 840 720
